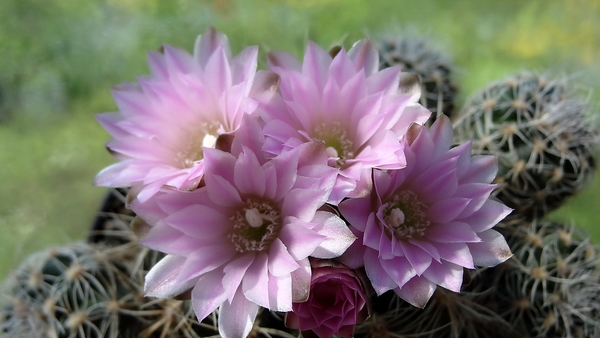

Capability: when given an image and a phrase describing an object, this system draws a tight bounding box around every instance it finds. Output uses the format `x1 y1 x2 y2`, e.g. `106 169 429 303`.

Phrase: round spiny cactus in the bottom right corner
473 220 600 338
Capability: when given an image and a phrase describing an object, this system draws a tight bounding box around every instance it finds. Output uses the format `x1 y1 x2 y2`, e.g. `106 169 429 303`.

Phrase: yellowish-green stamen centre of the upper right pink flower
312 122 354 167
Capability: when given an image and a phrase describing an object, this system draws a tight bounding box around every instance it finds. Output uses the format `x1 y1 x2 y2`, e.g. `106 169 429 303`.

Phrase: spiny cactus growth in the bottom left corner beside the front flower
0 243 217 338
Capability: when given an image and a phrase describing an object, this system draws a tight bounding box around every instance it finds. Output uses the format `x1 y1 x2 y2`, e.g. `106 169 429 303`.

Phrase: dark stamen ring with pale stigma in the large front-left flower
228 199 282 253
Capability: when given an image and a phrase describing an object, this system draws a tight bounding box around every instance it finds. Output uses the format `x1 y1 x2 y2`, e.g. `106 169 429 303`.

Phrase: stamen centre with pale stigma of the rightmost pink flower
383 190 431 240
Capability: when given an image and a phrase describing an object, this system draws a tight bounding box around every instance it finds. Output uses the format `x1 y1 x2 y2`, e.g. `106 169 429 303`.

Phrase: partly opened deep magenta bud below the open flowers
285 260 369 338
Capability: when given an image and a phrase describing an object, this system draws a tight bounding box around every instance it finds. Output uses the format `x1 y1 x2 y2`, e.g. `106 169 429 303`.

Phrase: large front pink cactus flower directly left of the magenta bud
132 115 356 338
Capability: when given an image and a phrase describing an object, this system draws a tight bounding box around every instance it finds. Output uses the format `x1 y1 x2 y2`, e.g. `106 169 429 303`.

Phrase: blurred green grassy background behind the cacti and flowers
0 0 600 278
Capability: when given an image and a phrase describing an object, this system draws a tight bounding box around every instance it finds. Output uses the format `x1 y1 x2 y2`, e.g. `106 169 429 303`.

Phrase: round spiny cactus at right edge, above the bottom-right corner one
455 72 598 220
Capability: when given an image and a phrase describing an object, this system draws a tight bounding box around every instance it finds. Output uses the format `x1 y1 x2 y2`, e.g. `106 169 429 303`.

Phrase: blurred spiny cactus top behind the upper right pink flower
377 34 458 124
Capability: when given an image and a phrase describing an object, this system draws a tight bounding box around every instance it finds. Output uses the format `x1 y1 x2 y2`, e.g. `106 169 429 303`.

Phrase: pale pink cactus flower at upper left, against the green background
94 28 258 201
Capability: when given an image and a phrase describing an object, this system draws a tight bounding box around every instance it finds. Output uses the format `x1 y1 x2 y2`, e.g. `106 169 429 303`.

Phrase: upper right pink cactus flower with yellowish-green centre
259 39 431 204
